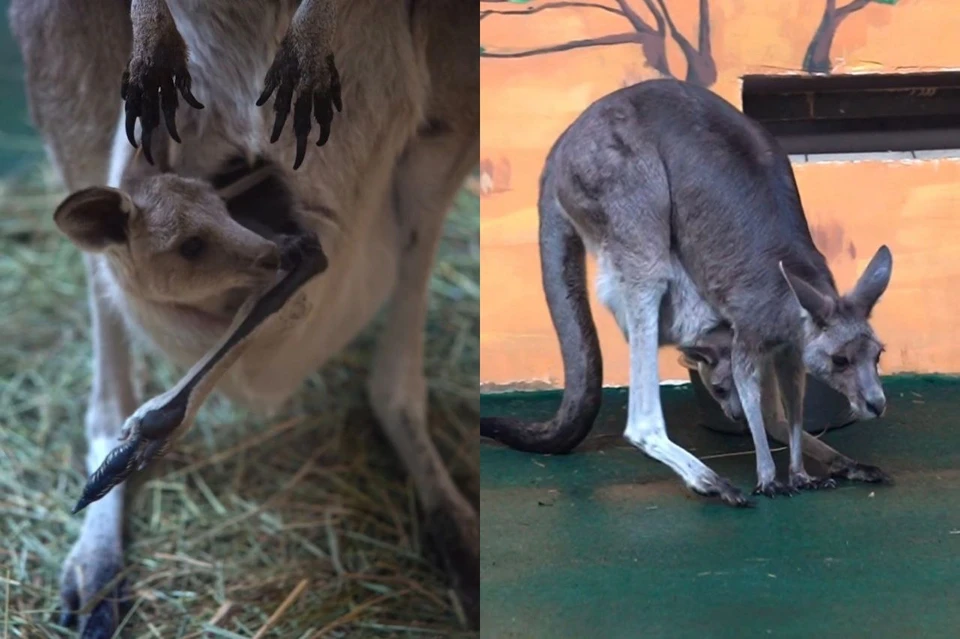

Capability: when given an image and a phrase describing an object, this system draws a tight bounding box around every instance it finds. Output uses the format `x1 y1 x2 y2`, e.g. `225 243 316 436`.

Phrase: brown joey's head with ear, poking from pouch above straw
54 174 280 322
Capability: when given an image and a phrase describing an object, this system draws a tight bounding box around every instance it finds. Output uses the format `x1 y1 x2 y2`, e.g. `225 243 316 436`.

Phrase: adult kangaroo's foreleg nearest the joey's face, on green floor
731 334 796 497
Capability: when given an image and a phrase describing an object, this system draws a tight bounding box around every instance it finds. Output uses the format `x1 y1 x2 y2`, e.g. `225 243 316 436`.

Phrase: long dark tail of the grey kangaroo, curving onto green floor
480 160 603 454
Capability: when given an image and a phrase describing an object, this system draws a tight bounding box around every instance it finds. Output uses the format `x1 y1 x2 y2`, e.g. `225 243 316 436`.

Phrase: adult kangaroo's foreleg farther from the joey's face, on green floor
773 349 837 490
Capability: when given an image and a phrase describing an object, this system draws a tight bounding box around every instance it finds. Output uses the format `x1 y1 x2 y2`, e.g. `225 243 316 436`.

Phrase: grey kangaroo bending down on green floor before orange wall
481 80 892 506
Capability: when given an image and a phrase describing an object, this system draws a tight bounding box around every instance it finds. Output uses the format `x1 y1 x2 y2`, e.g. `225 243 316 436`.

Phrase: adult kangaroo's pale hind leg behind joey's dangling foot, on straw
60 255 136 639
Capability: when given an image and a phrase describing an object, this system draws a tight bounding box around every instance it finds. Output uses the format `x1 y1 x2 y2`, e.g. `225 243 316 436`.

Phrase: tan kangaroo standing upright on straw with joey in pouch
10 0 479 637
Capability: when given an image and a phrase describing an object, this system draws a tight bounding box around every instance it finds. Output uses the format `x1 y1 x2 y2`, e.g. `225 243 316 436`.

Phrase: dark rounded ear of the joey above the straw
53 186 134 253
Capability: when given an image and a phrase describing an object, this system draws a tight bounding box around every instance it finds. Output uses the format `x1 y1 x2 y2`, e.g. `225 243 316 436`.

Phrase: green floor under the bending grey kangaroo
480 377 960 639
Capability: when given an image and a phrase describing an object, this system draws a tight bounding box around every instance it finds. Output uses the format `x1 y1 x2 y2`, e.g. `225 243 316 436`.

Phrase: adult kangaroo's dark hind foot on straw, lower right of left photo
424 498 480 629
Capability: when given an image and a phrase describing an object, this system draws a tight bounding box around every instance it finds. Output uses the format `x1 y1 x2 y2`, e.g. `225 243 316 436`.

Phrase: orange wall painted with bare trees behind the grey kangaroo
480 0 960 388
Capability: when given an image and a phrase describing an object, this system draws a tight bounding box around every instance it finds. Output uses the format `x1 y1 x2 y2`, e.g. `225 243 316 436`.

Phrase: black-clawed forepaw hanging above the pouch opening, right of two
257 31 343 171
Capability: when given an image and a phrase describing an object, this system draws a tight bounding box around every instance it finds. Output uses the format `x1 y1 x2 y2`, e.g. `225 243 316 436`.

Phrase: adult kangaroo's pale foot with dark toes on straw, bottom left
59 540 130 639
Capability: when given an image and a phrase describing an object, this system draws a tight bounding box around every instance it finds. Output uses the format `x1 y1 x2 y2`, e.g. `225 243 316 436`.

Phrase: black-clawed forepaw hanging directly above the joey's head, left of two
120 20 203 164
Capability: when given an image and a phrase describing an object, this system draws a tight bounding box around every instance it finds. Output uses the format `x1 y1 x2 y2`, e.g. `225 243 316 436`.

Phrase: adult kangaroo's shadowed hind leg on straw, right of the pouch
368 132 480 627
